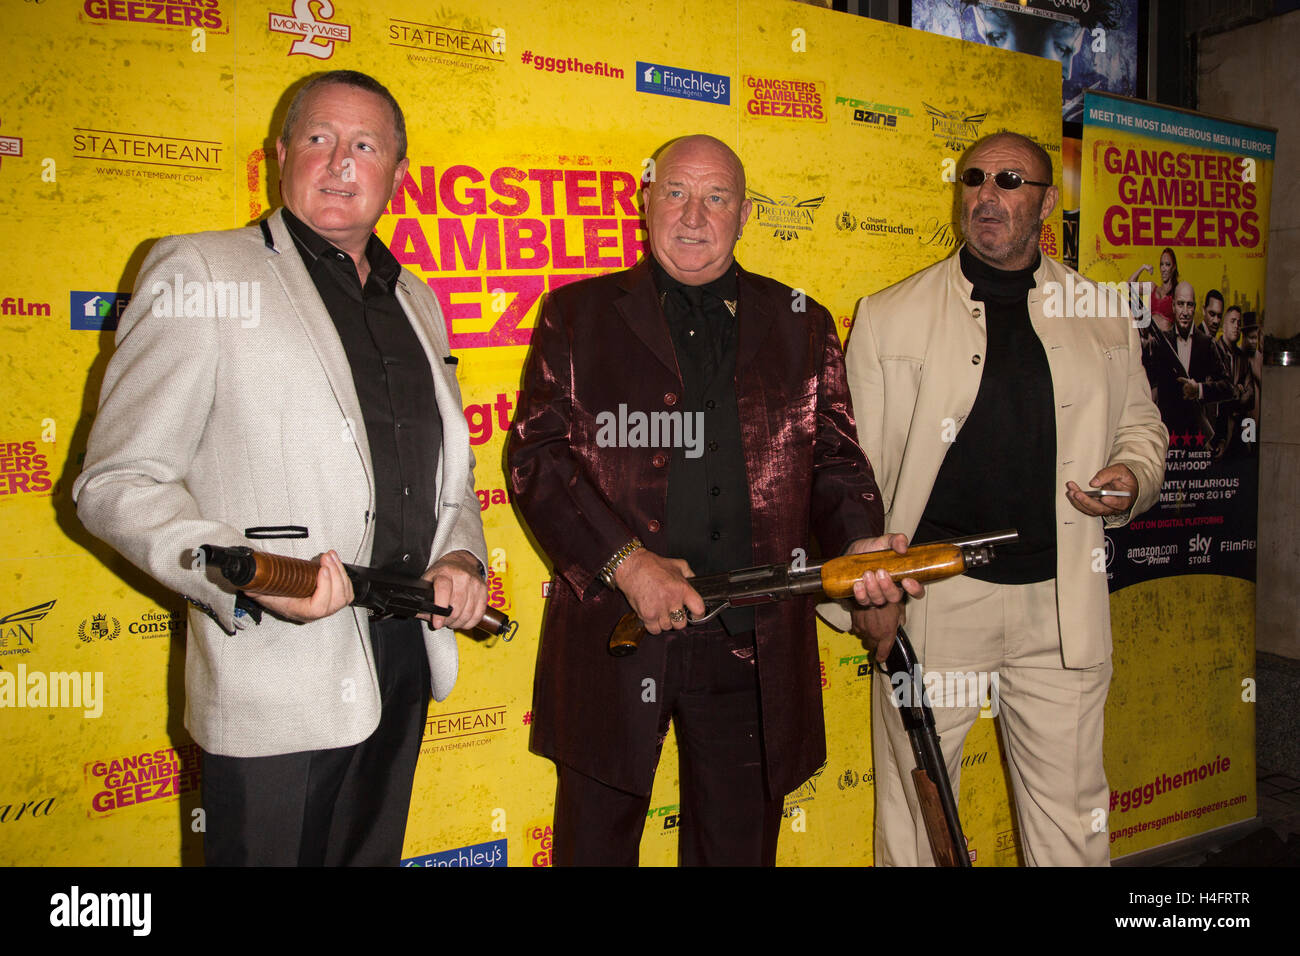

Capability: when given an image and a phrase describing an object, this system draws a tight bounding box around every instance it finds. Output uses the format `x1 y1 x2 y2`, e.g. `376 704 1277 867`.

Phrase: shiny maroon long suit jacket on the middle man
507 261 883 796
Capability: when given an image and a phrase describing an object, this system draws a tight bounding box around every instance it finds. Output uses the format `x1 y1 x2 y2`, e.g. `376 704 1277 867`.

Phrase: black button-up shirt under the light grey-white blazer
283 209 442 576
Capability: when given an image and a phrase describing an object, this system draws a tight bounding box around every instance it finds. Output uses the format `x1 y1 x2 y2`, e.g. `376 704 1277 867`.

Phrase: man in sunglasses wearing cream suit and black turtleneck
848 133 1167 865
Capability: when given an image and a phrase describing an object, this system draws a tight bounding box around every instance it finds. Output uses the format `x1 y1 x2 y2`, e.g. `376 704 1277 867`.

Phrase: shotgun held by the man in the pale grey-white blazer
200 545 519 636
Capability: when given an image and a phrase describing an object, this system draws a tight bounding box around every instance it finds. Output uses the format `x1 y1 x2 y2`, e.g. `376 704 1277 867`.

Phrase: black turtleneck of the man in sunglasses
915 246 1063 584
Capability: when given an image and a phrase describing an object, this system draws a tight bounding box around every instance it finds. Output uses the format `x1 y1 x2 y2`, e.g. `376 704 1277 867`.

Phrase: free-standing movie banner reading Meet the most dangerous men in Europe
1076 92 1275 856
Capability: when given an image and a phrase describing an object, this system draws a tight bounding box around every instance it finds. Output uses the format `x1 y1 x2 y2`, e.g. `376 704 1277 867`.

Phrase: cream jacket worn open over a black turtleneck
823 252 1169 667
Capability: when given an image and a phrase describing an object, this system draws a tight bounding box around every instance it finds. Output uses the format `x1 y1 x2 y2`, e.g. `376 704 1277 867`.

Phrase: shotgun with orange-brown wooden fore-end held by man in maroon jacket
610 531 1019 657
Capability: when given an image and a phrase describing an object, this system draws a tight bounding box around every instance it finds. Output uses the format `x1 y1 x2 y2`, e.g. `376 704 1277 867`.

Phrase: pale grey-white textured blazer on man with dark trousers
73 211 486 757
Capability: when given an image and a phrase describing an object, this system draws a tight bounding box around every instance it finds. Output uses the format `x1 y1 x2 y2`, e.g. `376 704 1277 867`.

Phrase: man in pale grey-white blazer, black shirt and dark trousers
73 70 486 865
